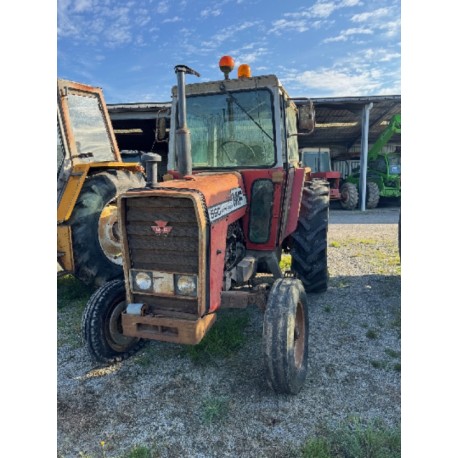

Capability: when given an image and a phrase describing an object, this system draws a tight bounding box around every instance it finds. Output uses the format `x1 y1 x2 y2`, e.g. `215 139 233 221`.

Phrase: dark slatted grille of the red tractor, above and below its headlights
125 196 199 319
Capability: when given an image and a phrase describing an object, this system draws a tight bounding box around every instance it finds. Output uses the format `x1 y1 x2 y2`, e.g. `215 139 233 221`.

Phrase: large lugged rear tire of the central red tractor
289 180 329 293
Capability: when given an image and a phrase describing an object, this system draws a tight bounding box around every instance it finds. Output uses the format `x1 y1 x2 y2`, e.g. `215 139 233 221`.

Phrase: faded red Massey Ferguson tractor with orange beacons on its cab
83 56 329 393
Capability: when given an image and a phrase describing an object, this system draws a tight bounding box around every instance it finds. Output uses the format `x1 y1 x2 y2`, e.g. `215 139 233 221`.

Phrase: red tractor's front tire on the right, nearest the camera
262 278 309 394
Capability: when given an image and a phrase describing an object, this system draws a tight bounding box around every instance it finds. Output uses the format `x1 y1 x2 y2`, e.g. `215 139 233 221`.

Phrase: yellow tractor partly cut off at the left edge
57 79 145 286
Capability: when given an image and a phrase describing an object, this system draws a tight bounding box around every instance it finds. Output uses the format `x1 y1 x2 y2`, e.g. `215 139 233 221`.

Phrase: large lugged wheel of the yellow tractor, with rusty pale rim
69 170 145 287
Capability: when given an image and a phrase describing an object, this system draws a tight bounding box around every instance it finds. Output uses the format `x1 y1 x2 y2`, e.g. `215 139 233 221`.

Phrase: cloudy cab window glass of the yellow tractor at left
68 93 115 162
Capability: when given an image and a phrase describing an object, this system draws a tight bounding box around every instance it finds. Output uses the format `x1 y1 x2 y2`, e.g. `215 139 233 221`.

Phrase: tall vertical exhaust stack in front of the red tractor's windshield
175 65 200 176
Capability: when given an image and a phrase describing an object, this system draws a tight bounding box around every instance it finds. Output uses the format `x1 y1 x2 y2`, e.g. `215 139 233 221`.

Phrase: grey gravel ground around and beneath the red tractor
57 208 401 458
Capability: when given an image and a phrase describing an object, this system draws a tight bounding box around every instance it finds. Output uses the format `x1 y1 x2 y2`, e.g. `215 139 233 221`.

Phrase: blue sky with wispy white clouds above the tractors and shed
57 0 401 103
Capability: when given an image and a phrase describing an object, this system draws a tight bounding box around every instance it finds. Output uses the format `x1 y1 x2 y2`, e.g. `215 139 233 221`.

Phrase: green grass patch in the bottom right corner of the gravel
299 420 401 458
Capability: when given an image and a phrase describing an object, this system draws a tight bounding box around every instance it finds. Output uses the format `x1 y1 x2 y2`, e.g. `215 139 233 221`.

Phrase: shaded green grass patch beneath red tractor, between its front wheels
184 310 249 364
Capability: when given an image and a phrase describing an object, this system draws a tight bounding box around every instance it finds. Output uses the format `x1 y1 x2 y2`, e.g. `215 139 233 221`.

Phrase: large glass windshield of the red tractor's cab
186 89 275 168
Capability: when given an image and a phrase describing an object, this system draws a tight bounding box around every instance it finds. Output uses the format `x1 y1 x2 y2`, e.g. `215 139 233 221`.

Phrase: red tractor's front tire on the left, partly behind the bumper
81 280 145 364
